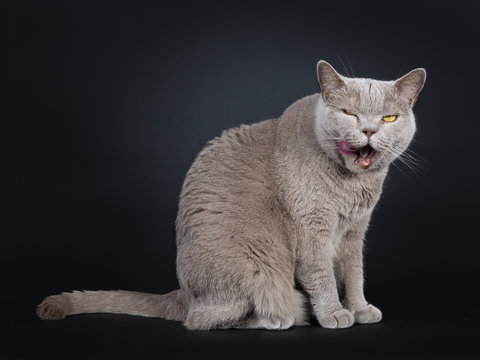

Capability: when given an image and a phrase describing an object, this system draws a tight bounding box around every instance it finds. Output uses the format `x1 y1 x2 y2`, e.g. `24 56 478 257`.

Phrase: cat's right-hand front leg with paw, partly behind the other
336 216 382 324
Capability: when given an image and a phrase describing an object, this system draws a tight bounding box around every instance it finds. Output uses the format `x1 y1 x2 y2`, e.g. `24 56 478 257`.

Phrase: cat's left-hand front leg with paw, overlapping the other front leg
295 221 354 329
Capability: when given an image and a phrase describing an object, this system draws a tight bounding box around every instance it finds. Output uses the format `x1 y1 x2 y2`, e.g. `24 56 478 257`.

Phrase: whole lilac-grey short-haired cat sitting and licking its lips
37 60 426 330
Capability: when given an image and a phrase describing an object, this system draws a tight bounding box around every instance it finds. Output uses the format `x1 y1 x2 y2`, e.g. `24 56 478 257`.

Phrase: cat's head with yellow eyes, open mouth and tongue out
315 60 426 173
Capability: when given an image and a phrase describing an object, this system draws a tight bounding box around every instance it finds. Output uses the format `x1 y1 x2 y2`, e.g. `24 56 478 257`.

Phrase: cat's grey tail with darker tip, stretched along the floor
37 289 188 321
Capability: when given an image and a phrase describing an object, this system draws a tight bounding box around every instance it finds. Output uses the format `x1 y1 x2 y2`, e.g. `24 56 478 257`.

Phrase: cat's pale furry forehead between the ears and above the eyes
333 78 407 115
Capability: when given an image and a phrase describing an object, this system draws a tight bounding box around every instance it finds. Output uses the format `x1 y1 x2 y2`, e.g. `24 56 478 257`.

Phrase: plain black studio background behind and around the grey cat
0 0 480 359
